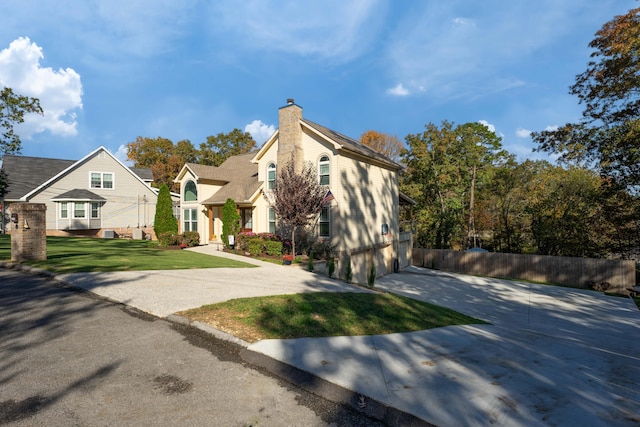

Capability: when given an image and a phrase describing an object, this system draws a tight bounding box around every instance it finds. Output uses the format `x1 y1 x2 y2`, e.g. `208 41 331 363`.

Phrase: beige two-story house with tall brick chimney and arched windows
176 99 411 283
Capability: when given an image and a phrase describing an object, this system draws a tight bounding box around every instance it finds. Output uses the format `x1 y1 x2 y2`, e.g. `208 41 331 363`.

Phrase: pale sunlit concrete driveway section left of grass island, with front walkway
58 246 364 317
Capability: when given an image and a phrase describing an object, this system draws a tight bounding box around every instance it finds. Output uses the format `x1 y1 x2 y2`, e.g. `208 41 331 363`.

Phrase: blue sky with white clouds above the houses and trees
0 0 638 166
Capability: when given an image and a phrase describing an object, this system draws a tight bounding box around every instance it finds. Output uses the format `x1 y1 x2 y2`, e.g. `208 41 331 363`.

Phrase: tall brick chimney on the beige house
278 98 304 172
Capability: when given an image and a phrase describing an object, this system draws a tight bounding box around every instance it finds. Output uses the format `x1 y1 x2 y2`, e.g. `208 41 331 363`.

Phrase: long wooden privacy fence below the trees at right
413 248 636 294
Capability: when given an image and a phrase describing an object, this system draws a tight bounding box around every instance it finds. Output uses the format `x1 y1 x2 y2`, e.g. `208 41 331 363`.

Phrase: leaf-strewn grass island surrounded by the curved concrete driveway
177 292 487 342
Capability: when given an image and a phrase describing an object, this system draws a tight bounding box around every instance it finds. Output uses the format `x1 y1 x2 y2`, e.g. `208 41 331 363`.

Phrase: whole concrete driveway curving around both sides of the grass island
53 247 640 426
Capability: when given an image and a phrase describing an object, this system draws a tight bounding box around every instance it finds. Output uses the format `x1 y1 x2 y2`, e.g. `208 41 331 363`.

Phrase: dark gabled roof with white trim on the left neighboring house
2 147 157 200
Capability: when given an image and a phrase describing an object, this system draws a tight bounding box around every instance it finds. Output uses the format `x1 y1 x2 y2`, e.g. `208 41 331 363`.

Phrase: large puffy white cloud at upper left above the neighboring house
0 37 82 139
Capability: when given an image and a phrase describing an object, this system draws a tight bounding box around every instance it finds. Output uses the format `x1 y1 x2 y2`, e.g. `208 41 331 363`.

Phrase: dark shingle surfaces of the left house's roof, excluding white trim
2 154 153 200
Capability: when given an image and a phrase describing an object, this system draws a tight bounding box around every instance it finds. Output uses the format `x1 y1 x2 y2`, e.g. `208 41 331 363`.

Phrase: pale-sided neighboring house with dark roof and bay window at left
2 147 158 236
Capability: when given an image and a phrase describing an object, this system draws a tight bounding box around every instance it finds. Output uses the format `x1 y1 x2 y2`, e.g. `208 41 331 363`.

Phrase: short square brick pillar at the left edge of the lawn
9 203 47 262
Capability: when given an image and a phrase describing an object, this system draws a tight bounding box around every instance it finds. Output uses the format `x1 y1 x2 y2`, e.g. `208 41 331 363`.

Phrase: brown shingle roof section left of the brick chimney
198 153 262 205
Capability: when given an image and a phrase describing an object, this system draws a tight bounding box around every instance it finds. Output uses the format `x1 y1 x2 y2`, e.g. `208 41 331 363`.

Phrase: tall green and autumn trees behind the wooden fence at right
400 8 640 258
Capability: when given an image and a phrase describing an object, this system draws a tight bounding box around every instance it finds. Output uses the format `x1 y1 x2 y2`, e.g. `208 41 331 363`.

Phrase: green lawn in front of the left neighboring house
0 234 254 273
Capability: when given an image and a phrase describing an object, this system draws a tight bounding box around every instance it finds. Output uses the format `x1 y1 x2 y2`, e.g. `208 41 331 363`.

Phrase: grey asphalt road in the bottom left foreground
0 270 380 426
